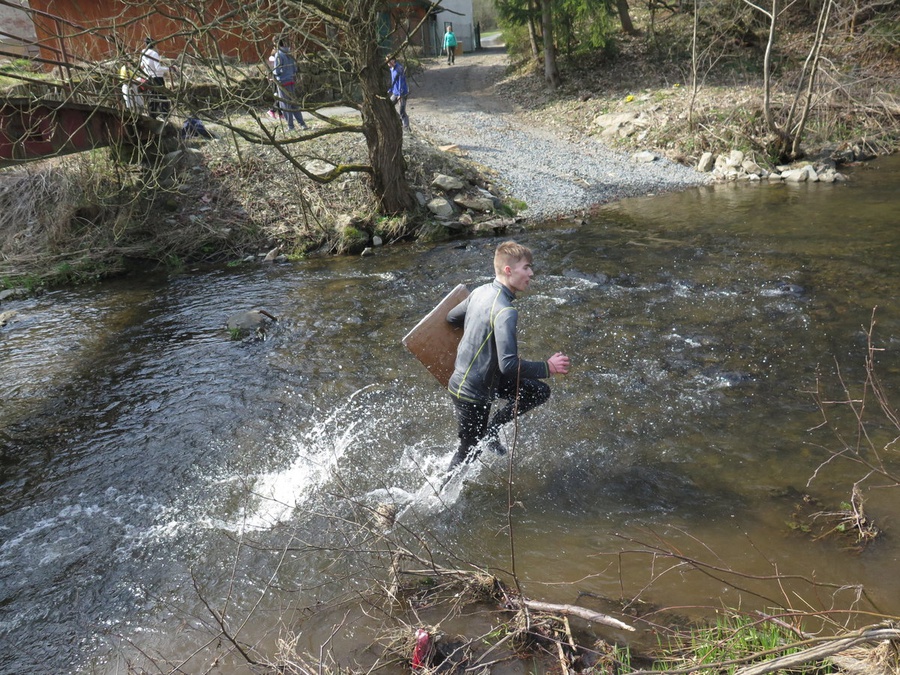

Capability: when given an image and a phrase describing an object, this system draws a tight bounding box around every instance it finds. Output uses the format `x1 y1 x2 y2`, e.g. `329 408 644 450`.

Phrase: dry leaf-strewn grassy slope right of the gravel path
502 6 900 166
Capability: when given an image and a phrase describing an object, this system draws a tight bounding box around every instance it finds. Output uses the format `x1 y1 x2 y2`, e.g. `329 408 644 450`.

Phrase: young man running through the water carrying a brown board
447 241 569 469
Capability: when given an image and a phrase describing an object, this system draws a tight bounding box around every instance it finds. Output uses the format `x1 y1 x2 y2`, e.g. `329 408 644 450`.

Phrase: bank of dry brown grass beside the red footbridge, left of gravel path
0 111 488 290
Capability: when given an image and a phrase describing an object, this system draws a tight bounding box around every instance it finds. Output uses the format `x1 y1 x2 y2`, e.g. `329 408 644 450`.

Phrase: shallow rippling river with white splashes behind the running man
0 157 900 673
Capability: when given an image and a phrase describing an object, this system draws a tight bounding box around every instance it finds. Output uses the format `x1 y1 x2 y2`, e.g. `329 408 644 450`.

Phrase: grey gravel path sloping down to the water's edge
408 38 710 220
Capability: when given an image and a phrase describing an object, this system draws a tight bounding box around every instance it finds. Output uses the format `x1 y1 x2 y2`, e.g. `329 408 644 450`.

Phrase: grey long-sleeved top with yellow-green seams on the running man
447 279 550 402
